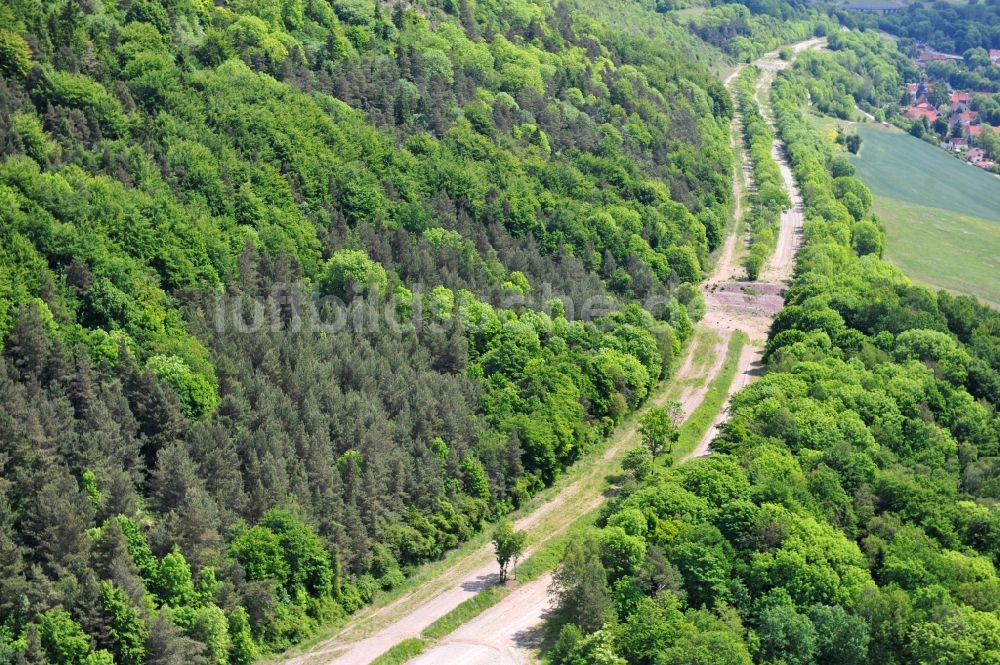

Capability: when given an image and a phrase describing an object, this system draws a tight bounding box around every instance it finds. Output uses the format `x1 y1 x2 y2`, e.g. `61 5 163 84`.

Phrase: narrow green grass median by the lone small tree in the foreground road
421 510 598 640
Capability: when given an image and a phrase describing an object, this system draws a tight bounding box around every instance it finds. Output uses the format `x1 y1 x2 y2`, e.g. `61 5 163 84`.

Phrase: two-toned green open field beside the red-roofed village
852 125 1000 307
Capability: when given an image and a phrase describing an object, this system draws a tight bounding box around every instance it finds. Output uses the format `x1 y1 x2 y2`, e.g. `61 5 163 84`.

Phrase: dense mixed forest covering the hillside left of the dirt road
0 0 744 665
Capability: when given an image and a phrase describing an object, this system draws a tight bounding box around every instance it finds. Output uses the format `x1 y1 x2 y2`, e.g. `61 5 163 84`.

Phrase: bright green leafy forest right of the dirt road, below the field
549 36 1000 665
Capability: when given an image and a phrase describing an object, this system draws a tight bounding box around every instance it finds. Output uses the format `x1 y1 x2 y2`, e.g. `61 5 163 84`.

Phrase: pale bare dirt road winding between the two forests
284 40 815 665
